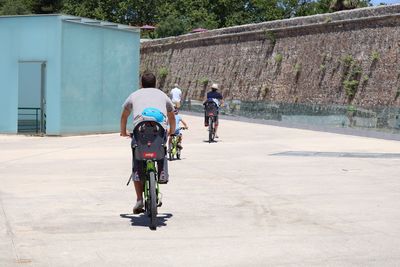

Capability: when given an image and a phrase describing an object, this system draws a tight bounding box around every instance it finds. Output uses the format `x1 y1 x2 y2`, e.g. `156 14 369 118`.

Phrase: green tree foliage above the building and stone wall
0 0 370 37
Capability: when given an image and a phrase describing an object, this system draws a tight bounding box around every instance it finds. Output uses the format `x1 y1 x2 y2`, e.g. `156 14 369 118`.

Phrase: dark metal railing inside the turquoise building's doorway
18 107 41 133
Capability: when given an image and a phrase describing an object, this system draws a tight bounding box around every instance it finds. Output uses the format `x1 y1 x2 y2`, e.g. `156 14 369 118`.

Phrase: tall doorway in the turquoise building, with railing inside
18 61 46 134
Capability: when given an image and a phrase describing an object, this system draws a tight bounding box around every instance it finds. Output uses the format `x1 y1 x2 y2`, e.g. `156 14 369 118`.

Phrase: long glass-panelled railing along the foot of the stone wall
181 100 400 134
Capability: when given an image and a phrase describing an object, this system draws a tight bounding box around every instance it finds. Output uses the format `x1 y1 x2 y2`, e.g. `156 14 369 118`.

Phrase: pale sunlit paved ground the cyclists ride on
0 115 400 266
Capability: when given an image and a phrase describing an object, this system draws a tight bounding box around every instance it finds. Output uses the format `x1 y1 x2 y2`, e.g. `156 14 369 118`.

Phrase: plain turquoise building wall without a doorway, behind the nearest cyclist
61 22 140 133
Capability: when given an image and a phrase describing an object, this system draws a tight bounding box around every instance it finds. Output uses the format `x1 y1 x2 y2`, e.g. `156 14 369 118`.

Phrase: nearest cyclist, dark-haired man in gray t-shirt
120 72 175 213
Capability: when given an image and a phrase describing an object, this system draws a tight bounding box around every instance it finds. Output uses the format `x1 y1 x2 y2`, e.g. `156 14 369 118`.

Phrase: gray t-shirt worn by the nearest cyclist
122 88 174 125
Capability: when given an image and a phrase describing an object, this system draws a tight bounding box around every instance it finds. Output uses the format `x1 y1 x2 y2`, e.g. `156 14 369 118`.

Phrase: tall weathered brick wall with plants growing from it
141 5 400 107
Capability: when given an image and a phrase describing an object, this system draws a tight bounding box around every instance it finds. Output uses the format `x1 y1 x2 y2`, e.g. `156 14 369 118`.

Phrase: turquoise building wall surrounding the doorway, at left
0 16 61 134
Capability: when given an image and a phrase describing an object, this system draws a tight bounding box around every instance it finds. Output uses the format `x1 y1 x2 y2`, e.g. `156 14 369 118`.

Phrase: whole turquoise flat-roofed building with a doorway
0 15 140 135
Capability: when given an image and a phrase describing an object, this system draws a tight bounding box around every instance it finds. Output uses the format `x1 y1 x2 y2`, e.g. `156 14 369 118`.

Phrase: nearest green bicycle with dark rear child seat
128 121 166 230
